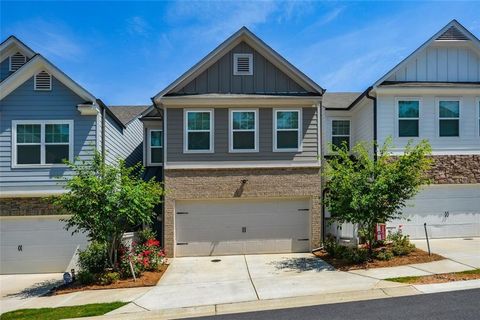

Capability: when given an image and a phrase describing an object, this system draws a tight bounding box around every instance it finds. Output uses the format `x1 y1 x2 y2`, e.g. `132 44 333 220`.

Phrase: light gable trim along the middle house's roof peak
154 27 325 102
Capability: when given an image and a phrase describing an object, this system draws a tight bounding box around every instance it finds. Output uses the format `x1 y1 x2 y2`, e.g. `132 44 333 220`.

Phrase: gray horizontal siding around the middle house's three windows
167 108 318 163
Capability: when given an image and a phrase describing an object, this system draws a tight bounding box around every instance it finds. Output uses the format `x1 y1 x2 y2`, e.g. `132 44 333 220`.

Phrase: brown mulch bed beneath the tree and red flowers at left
49 264 168 295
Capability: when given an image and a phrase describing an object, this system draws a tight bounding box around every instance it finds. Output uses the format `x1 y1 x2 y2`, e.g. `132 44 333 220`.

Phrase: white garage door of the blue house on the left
0 216 87 274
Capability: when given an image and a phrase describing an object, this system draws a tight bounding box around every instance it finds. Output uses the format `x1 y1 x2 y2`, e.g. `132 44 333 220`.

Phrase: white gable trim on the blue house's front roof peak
0 55 96 103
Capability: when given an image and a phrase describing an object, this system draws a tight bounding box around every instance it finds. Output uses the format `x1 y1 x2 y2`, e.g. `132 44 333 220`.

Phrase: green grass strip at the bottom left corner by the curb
0 302 127 320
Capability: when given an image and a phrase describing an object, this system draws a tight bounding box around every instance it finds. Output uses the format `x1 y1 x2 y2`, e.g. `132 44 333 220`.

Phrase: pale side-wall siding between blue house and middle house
105 114 143 166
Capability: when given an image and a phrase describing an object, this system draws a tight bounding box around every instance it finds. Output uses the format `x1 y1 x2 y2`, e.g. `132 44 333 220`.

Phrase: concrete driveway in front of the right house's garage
412 238 480 268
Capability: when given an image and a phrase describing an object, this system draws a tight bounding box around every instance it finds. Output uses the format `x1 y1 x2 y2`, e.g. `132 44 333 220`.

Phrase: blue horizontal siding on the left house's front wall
0 77 97 193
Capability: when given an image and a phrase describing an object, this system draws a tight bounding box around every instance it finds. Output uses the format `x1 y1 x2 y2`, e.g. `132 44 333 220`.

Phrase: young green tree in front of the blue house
52 152 163 267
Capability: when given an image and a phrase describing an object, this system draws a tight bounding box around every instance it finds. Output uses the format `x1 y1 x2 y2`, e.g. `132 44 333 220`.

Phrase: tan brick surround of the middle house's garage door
164 168 322 257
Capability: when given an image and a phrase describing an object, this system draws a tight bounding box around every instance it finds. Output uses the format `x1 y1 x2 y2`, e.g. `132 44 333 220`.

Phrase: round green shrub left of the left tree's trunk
78 241 108 274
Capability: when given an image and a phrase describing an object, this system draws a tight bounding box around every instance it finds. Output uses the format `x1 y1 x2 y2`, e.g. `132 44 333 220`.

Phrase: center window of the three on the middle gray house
229 109 258 152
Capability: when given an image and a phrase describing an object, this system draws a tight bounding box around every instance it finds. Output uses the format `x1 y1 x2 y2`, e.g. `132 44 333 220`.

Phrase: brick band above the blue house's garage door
0 197 62 216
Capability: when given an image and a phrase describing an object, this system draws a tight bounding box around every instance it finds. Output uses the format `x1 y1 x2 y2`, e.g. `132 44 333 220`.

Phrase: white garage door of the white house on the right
388 184 480 239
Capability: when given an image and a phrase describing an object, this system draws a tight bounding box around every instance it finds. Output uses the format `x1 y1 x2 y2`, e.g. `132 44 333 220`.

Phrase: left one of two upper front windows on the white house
398 100 420 137
